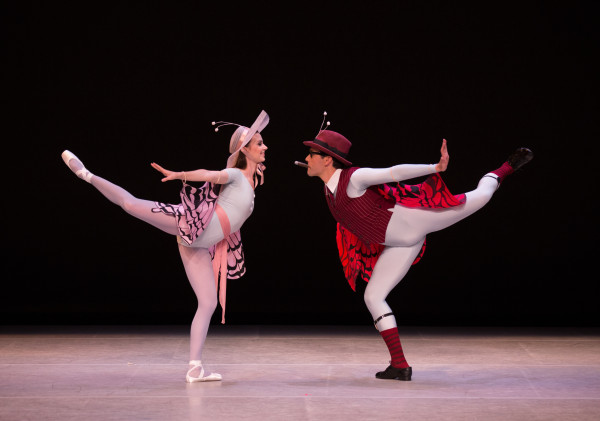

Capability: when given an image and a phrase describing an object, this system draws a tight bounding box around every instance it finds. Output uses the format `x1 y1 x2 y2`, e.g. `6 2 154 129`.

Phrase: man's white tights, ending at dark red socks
364 174 498 332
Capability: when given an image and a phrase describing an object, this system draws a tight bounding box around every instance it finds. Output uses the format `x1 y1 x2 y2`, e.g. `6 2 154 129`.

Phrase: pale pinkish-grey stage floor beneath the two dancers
0 325 600 421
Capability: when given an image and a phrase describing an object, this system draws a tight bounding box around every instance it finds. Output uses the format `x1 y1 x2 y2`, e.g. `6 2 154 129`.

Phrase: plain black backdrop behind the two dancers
0 1 600 325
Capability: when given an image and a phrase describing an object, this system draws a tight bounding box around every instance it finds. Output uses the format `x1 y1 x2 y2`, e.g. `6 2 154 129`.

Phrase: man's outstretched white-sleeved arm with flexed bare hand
348 139 450 197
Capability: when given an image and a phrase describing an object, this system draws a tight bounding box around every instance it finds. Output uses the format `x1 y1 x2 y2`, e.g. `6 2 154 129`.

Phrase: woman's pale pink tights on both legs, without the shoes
91 175 217 368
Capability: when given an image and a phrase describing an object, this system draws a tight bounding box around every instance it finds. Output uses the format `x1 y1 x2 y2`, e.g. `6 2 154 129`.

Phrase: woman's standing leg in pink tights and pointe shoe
179 244 221 383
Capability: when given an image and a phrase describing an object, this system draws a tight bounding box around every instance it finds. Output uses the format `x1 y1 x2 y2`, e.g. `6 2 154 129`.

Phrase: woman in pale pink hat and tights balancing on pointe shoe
62 111 269 383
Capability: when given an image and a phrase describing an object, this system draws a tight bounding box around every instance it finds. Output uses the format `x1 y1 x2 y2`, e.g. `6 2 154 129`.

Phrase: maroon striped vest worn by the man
325 167 396 244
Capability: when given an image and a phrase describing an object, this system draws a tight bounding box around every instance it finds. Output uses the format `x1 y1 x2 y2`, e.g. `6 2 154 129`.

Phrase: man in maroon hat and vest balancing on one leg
303 123 533 380
